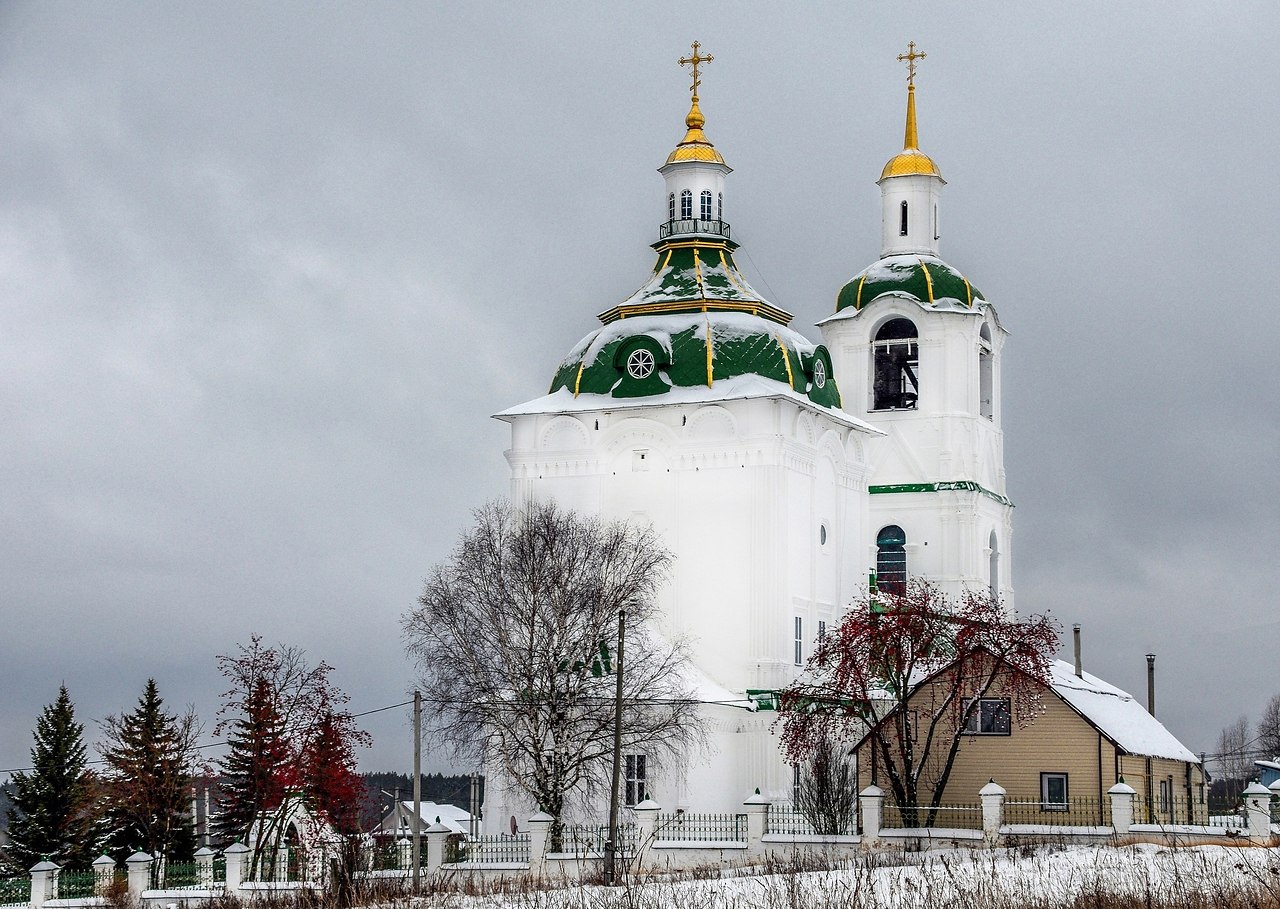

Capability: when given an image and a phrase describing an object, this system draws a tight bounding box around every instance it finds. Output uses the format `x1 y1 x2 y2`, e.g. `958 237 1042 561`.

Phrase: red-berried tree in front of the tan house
778 580 1059 826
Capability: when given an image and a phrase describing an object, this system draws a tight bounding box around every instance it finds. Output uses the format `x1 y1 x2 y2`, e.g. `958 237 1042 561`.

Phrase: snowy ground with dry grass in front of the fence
414 845 1280 909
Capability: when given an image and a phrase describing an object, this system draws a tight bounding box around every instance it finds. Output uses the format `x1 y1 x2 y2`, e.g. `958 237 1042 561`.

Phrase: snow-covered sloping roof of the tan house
1050 659 1199 764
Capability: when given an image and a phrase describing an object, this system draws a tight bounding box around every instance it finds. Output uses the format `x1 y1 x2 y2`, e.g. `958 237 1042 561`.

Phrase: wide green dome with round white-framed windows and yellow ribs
550 311 840 407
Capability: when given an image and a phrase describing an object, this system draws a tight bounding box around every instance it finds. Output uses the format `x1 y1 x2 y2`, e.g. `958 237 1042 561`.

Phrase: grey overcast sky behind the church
0 0 1280 777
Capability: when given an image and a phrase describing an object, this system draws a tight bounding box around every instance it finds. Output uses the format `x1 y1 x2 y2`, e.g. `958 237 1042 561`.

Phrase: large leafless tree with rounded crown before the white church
402 502 700 839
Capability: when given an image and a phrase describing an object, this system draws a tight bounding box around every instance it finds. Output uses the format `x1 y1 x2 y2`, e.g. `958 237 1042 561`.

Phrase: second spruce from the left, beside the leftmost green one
102 679 198 862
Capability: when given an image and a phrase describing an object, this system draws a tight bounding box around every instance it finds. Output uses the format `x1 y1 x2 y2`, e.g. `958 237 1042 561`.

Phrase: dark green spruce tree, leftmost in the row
5 685 99 868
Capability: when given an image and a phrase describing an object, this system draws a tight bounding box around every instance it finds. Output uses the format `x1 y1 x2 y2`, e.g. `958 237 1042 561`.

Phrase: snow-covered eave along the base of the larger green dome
493 374 883 435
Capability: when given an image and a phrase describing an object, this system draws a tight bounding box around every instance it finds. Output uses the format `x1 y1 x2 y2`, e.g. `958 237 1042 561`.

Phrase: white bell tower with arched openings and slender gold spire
819 42 1014 604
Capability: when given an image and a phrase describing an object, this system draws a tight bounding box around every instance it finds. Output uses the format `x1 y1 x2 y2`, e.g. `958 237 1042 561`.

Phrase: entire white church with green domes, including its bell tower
485 45 1014 831
